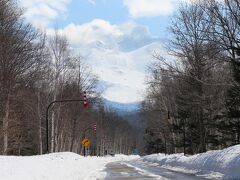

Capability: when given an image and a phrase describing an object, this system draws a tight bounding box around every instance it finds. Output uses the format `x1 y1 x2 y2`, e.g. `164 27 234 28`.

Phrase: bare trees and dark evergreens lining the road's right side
142 0 240 154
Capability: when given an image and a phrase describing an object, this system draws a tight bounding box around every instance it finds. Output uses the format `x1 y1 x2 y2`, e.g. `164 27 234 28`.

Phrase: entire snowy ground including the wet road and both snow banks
0 145 240 180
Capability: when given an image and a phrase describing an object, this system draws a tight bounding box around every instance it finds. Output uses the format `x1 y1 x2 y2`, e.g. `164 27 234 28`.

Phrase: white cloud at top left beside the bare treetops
20 0 71 27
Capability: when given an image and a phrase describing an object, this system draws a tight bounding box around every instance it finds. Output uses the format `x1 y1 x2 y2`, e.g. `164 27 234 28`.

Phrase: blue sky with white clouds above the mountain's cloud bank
20 0 182 37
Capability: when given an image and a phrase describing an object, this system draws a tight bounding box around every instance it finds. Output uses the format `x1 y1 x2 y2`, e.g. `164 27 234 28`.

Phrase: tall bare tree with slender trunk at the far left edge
0 0 45 154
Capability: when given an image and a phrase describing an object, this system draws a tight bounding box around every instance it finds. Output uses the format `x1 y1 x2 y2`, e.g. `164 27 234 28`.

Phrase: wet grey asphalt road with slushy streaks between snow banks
104 160 209 180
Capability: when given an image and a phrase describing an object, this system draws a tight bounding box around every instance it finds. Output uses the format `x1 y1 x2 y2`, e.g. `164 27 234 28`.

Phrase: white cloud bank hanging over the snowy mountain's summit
47 19 156 51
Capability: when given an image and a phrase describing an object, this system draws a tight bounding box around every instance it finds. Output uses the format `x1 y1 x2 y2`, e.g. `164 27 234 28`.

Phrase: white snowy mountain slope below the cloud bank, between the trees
79 41 166 103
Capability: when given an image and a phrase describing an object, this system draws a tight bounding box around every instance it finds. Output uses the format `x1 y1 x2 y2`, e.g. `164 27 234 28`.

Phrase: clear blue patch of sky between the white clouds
50 0 170 37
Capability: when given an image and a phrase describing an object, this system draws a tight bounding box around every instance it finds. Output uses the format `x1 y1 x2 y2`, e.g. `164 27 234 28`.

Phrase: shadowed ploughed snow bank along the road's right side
143 145 240 179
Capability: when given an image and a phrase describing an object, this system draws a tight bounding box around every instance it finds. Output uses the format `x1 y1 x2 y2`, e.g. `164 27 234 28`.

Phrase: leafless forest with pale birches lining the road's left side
0 0 135 155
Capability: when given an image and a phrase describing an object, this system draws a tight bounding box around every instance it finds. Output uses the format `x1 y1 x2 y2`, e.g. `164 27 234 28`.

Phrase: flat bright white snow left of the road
0 152 139 180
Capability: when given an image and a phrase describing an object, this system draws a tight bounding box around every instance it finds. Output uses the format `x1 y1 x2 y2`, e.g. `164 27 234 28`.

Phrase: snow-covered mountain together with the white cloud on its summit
47 19 166 103
